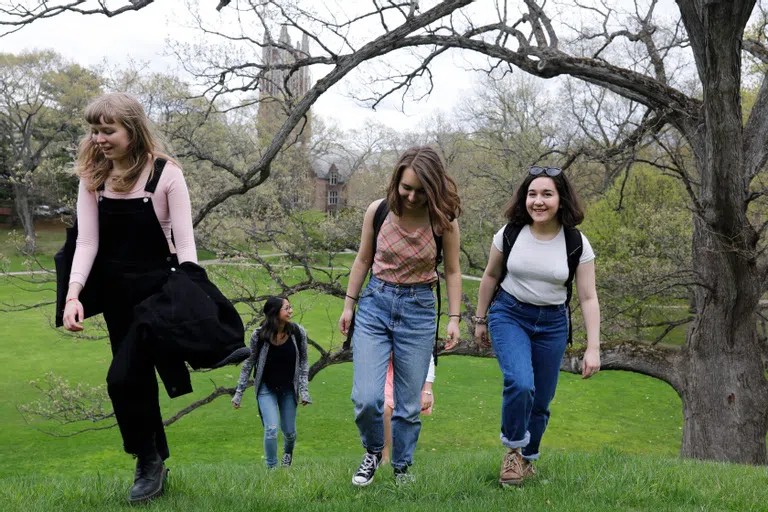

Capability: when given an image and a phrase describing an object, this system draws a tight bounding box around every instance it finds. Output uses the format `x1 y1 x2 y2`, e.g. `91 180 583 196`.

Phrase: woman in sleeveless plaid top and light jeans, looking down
339 146 461 486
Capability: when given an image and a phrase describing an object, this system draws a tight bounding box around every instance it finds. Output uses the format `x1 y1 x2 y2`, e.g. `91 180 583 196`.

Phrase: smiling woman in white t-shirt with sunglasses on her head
475 167 600 485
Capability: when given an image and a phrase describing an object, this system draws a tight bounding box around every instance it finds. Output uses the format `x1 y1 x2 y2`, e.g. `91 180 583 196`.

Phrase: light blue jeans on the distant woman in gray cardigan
256 384 296 468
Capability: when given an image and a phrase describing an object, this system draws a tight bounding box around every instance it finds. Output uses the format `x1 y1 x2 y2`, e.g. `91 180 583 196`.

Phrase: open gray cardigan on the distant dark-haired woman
232 324 312 405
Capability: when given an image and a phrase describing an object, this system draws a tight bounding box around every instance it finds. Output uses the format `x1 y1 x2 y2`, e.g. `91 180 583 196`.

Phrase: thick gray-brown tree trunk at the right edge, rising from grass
678 2 768 464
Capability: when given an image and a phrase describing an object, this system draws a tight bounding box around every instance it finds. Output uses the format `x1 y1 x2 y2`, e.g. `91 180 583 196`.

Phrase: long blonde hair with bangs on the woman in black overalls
75 92 178 192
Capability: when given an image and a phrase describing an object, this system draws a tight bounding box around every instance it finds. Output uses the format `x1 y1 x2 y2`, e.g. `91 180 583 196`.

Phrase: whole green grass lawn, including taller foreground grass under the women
0 222 768 511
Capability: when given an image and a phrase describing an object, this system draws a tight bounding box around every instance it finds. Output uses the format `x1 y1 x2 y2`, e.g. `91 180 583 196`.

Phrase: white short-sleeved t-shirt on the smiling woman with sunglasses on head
493 225 595 306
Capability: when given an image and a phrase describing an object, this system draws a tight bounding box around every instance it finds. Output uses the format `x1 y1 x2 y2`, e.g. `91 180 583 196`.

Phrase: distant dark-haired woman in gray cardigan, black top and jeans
232 297 312 469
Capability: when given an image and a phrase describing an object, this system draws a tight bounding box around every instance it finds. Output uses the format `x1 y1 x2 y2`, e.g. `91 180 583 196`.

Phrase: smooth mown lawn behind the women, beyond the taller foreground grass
0 268 682 477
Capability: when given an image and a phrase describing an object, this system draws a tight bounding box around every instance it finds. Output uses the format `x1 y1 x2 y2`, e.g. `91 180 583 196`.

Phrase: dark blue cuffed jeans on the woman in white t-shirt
488 290 568 460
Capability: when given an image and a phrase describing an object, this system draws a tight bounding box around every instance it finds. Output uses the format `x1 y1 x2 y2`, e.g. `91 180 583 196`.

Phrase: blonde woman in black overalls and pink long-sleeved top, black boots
63 93 197 502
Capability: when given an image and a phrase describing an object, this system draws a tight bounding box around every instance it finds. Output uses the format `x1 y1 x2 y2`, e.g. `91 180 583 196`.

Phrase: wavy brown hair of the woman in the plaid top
387 146 461 233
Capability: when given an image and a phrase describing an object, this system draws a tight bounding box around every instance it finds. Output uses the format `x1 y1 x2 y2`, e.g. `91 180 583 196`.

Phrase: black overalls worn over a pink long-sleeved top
93 159 178 459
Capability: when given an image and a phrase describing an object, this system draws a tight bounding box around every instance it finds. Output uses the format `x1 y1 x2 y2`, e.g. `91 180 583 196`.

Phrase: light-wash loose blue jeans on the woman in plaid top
352 277 437 469
